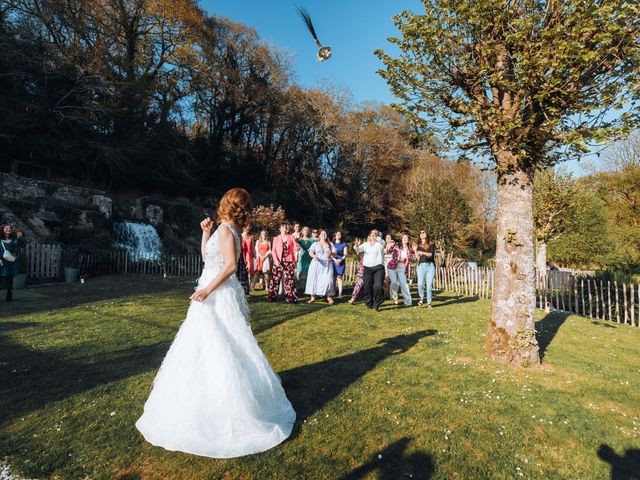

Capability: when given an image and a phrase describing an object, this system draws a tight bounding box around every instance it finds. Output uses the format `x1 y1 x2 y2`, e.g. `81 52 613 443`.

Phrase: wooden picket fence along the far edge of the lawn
18 243 640 327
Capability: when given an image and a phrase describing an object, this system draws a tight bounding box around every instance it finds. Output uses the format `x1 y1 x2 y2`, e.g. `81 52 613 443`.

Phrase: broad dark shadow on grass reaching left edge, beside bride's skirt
0 338 170 425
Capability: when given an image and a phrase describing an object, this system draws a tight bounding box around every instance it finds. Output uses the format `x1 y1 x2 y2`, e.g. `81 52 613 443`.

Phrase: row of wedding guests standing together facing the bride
239 223 435 310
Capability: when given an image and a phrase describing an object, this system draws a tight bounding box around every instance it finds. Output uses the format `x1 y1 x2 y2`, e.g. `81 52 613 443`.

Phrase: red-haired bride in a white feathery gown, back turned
136 188 296 458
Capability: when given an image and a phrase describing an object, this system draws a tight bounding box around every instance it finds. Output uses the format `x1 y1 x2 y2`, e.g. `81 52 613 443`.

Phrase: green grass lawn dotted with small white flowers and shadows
0 276 640 480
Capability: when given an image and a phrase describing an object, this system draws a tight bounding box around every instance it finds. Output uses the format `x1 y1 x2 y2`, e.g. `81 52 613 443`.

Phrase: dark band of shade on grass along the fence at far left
1 275 189 317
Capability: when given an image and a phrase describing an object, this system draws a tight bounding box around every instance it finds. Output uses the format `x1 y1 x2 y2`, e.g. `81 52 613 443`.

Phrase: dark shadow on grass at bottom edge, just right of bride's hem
340 437 434 480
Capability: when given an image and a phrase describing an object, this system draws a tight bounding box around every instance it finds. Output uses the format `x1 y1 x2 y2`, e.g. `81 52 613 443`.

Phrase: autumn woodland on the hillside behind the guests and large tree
0 0 640 273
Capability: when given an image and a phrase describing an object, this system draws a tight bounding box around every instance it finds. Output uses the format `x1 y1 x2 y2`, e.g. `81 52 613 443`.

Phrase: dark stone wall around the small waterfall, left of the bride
0 172 206 250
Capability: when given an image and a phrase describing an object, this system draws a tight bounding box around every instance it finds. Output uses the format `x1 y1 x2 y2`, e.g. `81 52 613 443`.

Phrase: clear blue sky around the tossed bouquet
200 0 598 175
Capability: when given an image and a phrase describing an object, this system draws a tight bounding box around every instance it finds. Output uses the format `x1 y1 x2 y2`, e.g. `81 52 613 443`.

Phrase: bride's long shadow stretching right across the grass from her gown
280 329 438 437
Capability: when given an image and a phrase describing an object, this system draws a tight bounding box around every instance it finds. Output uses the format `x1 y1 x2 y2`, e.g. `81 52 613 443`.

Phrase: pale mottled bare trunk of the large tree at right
486 163 540 366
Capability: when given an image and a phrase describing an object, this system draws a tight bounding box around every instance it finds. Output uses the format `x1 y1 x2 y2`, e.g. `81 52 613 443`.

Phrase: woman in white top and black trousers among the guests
355 229 385 310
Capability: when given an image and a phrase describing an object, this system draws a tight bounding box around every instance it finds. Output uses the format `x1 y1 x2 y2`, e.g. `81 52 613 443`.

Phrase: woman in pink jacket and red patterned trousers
269 223 300 303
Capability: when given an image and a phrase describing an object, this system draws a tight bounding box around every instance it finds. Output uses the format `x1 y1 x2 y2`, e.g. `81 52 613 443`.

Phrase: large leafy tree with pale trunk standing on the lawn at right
377 0 640 365
